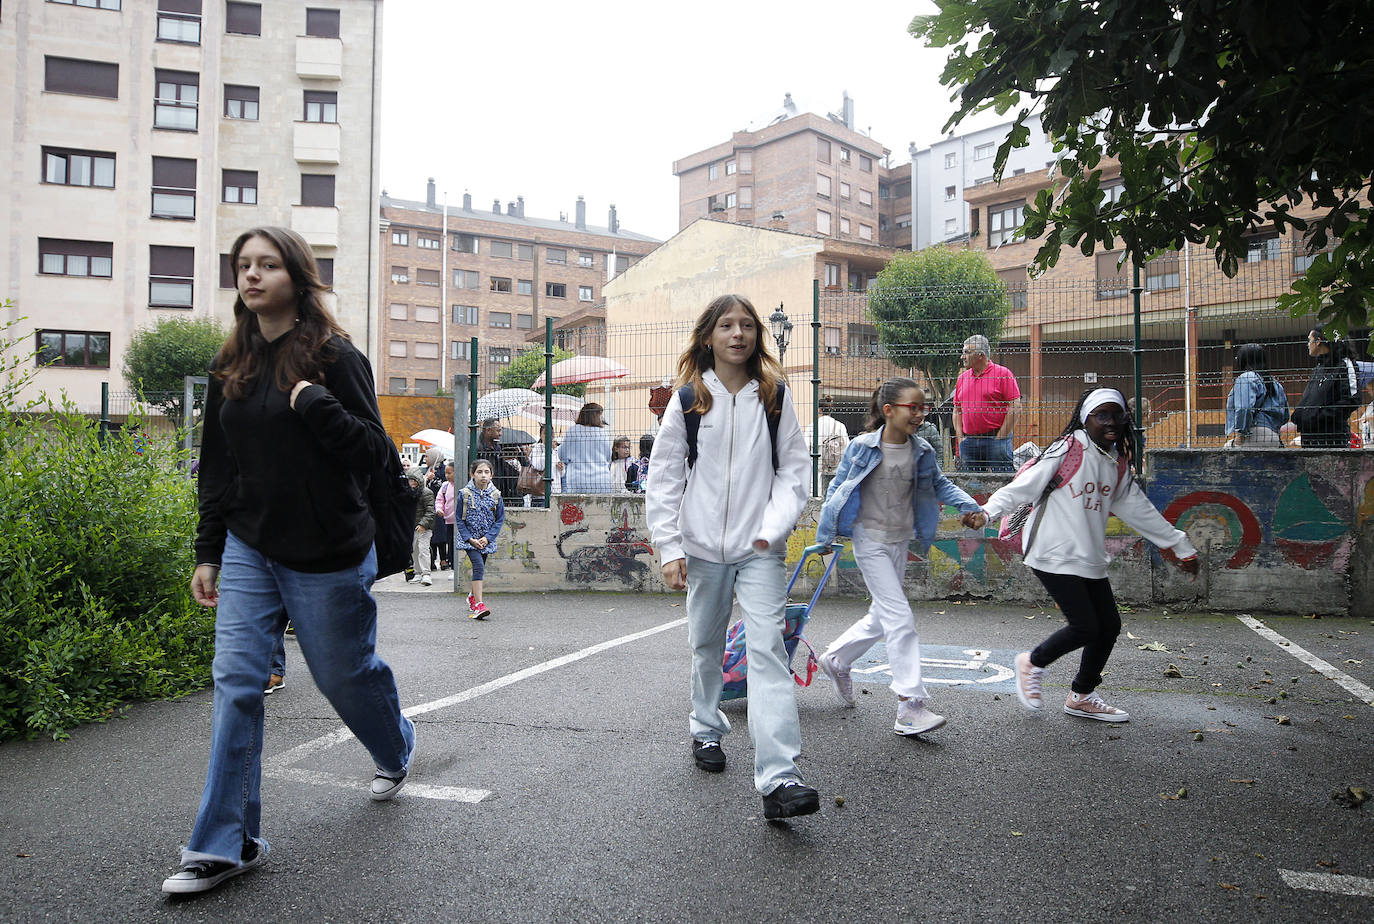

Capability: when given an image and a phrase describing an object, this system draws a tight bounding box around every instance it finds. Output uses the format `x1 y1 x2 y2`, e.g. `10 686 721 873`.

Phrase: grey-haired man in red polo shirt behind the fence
954 334 1021 472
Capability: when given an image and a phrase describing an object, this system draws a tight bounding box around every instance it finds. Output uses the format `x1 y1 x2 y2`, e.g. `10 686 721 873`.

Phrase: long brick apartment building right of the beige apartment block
376 180 658 395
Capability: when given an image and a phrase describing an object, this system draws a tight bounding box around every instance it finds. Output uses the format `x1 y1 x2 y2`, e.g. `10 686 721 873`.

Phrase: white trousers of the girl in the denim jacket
826 524 926 700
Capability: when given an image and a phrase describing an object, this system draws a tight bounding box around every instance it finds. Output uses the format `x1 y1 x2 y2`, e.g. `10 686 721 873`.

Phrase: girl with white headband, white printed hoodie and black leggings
971 388 1198 722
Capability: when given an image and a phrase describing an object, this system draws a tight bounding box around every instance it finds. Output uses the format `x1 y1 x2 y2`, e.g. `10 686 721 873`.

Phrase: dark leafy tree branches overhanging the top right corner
910 0 1374 330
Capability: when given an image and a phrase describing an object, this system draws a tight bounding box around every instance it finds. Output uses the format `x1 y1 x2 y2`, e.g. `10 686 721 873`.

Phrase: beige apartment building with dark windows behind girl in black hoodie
0 0 382 408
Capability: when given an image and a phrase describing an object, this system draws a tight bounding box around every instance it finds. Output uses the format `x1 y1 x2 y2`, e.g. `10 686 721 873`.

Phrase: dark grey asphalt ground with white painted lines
0 575 1374 921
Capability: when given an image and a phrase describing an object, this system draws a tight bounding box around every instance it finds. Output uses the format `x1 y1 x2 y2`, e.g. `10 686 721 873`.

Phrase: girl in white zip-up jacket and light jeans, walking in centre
646 296 820 818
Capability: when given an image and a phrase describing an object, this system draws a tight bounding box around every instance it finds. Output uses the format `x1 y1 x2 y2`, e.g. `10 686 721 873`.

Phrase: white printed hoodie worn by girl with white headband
982 430 1197 578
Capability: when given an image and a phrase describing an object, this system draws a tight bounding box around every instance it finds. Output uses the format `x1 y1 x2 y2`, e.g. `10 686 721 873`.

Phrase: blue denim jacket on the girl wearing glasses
816 429 982 557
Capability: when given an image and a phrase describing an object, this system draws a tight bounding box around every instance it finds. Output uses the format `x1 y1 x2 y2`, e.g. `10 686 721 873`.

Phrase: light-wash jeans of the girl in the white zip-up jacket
687 553 801 793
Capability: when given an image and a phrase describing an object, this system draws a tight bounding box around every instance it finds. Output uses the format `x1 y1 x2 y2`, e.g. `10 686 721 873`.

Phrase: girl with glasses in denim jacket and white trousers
816 377 982 734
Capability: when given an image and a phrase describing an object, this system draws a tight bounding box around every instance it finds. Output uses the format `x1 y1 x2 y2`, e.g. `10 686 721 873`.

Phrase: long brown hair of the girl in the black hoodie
214 227 349 400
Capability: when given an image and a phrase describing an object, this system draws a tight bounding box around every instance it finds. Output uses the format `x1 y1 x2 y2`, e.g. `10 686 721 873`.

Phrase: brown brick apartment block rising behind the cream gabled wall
673 95 911 248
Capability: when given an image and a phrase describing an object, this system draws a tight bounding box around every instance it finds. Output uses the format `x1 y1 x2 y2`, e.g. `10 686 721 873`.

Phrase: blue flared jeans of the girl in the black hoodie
181 532 415 864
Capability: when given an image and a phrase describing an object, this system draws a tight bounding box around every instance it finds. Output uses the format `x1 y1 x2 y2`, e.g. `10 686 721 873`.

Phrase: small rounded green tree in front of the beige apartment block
124 318 225 421
